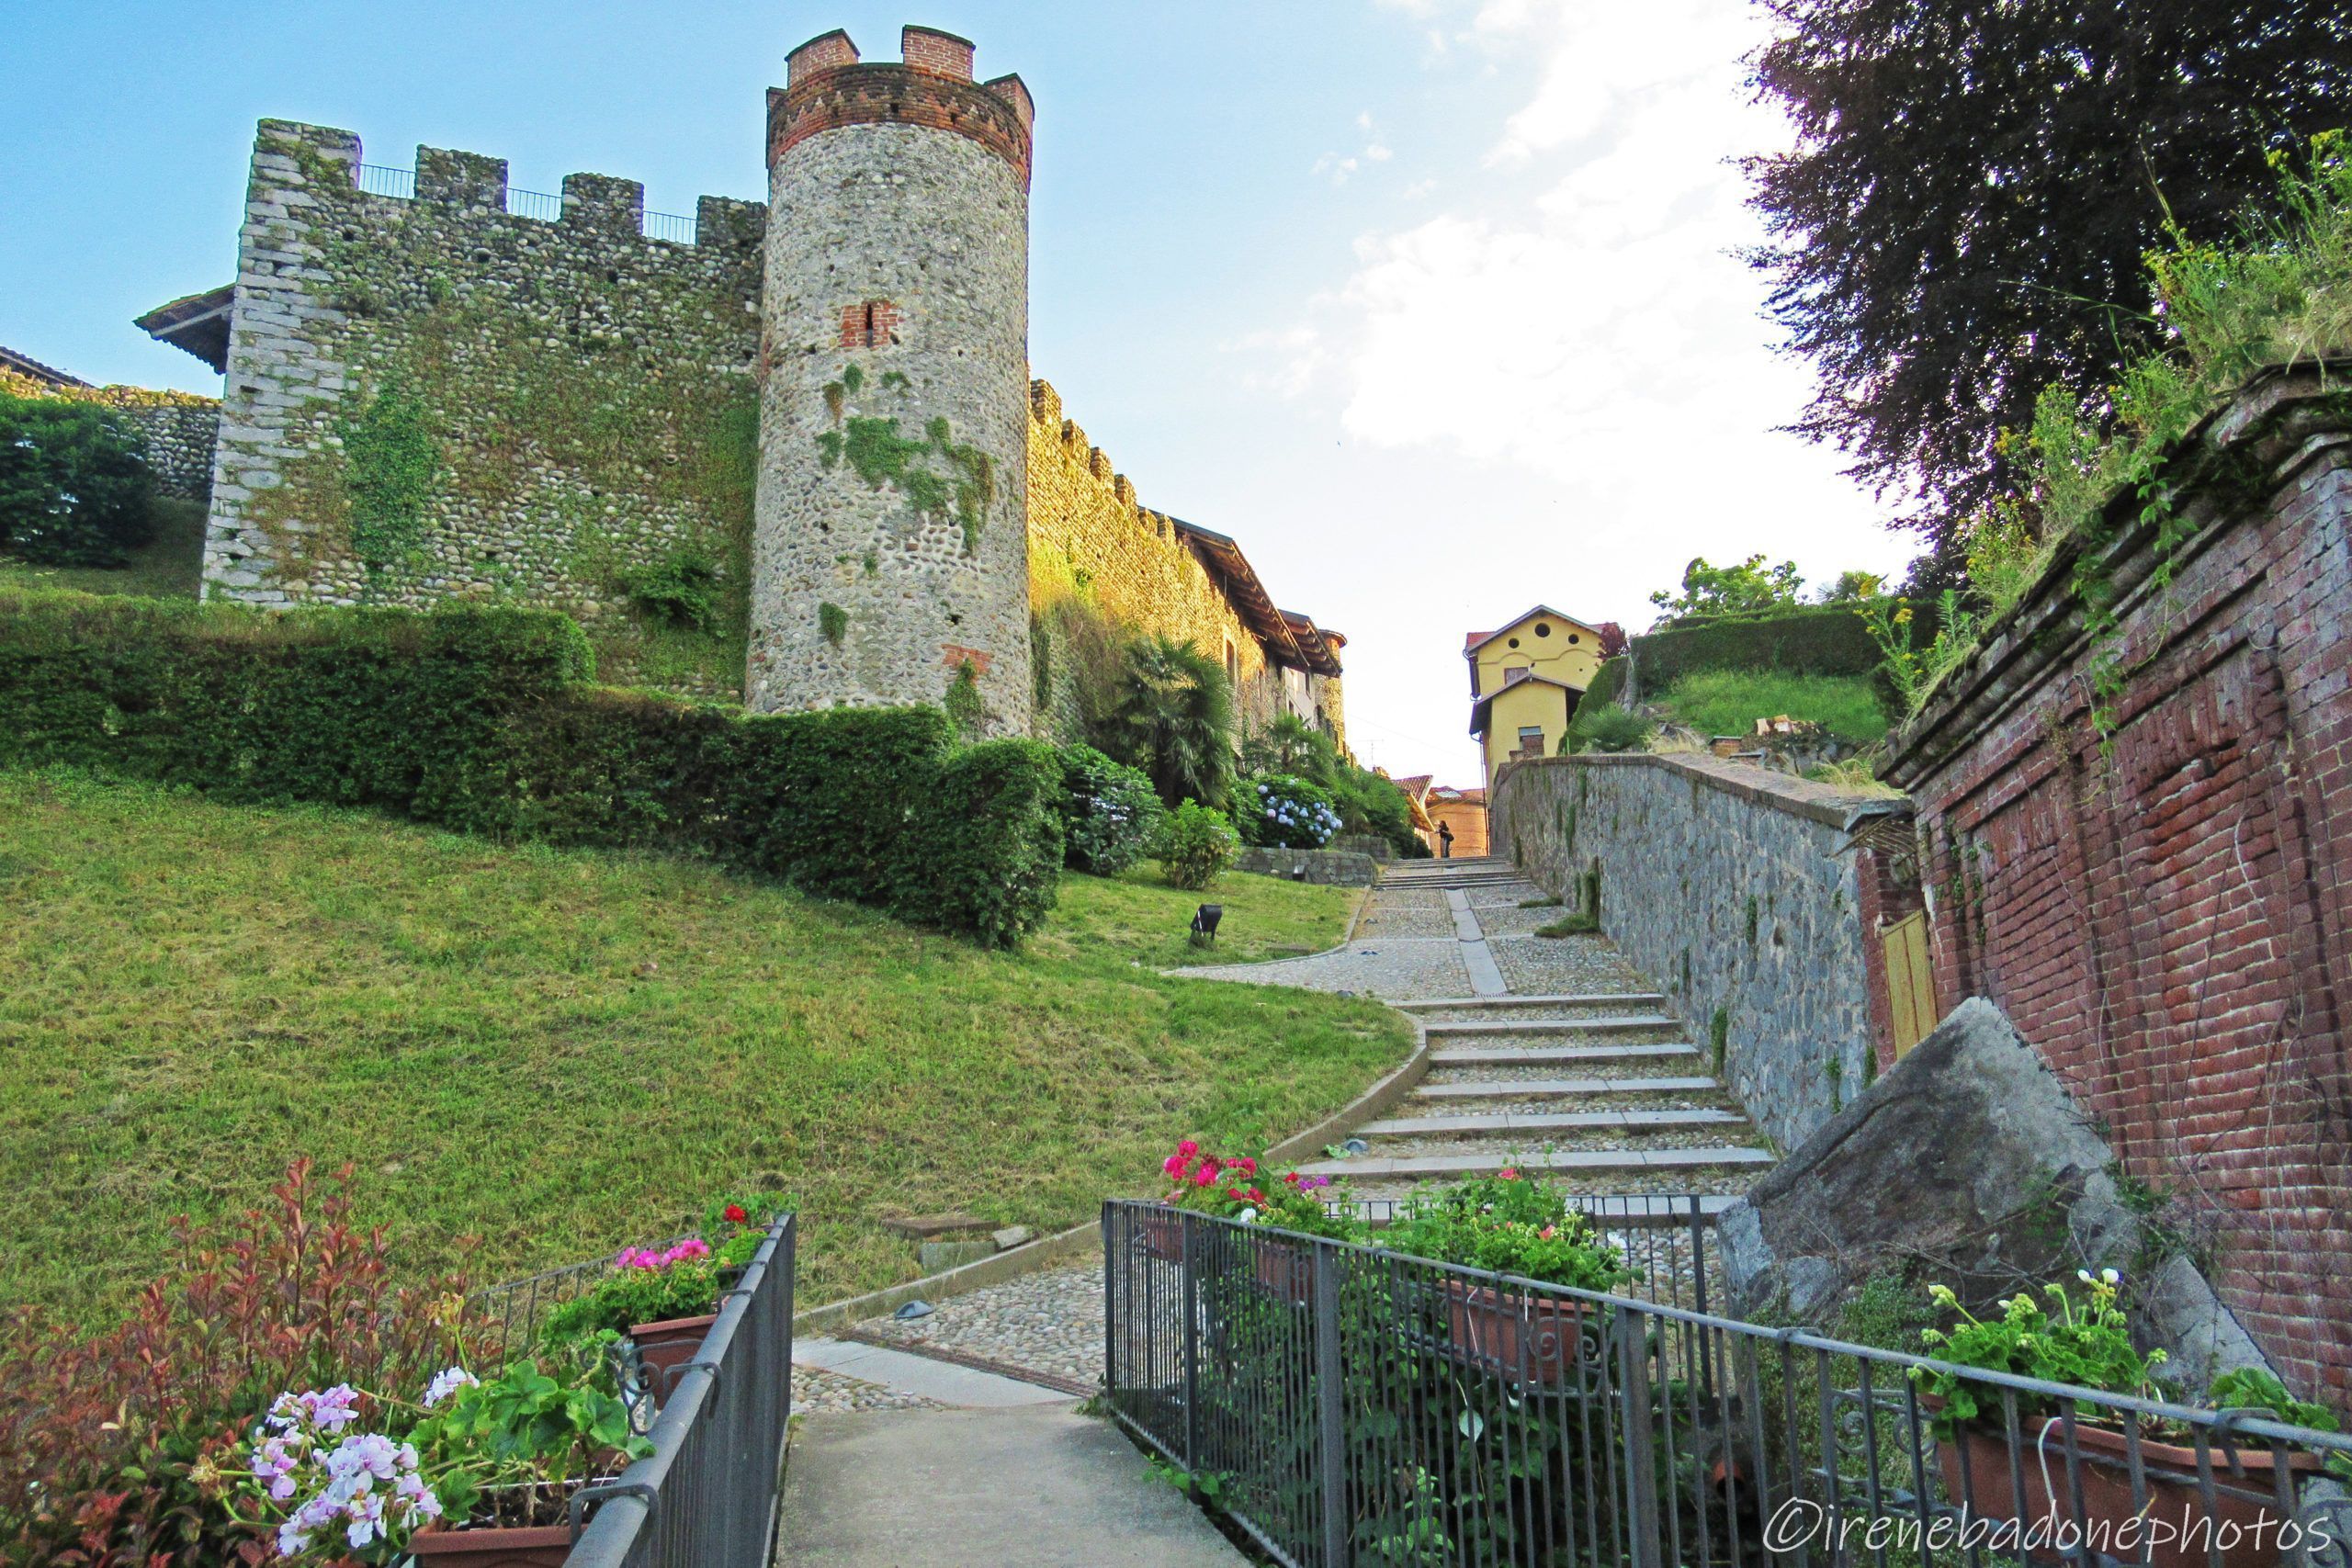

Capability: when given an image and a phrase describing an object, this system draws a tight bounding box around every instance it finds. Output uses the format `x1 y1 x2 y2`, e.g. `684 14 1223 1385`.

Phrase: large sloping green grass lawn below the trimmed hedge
0 773 1408 1316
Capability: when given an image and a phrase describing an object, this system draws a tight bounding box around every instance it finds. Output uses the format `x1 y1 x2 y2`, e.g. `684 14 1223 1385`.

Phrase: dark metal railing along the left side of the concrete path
454 1215 799 1568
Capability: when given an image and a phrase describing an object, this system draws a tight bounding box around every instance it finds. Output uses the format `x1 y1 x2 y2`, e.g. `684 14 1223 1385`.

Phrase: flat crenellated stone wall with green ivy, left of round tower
205 120 767 696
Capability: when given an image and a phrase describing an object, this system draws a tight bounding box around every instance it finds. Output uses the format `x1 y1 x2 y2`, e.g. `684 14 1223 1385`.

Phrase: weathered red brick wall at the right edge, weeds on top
1894 385 2352 1408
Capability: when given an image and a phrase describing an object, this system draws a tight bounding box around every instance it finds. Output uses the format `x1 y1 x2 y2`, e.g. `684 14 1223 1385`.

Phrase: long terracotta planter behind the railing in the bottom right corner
1919 1399 2319 1568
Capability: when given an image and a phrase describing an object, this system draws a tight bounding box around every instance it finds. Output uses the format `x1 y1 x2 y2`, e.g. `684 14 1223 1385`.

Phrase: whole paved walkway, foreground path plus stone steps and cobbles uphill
781 861 1773 1568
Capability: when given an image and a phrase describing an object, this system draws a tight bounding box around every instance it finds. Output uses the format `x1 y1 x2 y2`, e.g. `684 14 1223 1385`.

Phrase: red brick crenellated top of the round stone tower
767 26 1037 186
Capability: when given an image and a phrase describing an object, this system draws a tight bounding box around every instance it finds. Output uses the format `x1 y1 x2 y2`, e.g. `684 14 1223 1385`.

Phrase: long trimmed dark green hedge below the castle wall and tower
0 592 1061 945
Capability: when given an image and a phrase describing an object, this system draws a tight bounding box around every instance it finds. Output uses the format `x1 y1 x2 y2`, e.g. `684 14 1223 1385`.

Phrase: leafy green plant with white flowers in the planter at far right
1912 1269 2164 1432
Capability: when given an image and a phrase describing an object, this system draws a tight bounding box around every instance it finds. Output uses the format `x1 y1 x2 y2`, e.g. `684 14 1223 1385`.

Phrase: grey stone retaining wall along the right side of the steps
1488 755 1910 1147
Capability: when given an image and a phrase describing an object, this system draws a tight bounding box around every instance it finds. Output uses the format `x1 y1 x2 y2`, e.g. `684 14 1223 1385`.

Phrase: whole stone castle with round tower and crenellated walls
141 28 1345 739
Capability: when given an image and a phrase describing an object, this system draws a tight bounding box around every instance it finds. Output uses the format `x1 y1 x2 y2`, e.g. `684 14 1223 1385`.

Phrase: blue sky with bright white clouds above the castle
0 0 1910 783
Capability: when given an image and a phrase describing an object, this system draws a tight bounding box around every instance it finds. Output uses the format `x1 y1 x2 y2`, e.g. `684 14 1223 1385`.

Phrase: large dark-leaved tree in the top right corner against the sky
1747 0 2352 558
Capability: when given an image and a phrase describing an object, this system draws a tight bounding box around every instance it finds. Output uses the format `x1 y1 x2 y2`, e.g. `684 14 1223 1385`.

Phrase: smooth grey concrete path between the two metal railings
778 1399 1247 1568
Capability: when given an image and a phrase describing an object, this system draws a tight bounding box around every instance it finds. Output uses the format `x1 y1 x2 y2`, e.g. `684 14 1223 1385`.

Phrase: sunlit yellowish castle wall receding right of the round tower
1028 381 1348 743
